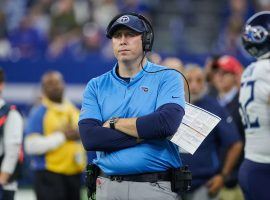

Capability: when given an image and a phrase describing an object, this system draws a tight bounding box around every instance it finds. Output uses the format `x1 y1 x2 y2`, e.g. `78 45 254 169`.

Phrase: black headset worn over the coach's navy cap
106 12 154 52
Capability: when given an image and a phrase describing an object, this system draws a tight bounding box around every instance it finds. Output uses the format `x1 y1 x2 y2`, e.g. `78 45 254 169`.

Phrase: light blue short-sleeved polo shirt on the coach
80 62 185 175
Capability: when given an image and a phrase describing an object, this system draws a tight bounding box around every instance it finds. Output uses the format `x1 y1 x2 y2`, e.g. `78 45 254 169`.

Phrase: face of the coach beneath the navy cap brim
112 27 143 62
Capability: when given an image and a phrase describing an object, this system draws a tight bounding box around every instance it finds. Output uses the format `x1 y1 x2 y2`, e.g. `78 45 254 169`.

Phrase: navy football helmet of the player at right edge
242 11 270 58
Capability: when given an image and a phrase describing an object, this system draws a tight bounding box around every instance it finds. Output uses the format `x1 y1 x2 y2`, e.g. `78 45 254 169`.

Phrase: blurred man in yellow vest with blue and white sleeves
25 71 86 200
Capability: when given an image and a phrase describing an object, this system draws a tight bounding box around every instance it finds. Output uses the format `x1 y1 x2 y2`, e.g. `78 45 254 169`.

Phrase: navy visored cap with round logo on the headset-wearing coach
106 15 147 39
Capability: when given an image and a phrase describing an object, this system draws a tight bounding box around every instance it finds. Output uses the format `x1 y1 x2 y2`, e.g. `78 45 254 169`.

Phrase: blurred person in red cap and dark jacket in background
213 55 245 200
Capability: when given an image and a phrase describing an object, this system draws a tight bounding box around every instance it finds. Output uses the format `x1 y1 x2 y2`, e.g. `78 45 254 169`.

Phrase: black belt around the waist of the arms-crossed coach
100 171 171 183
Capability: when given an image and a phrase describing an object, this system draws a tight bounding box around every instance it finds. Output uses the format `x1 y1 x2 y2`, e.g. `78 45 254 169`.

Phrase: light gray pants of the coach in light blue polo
96 176 181 200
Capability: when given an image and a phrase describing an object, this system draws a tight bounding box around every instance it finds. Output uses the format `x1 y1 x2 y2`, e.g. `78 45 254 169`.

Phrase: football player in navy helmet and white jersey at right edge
239 11 270 200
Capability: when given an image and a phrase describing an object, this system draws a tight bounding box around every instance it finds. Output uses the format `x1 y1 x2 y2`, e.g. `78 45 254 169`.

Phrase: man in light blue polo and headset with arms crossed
79 13 185 200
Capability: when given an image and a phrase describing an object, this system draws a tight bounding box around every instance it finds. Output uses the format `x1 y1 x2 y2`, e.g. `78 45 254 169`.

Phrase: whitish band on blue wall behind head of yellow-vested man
3 84 86 104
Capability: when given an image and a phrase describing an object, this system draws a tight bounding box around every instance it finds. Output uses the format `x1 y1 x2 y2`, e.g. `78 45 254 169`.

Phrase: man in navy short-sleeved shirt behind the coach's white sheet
181 66 243 200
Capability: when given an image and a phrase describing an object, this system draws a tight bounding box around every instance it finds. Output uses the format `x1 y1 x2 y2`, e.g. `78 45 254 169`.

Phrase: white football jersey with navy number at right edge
239 59 270 163
